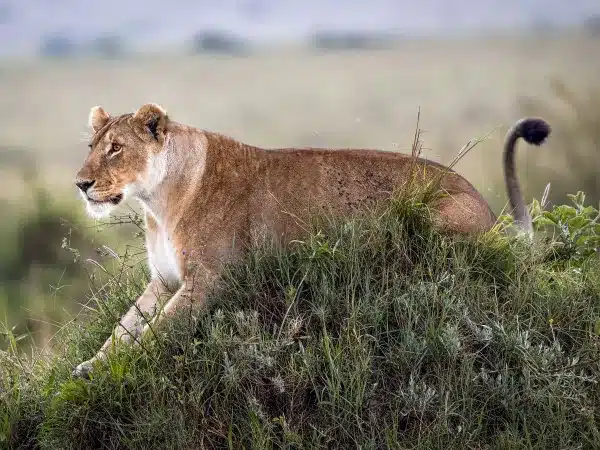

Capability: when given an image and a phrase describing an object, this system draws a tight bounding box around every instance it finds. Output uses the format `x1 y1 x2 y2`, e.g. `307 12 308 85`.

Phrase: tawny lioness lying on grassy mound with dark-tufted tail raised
73 104 550 376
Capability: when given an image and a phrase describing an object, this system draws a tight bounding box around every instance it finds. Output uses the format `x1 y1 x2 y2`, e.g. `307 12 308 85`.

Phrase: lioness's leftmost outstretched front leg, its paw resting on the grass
73 279 171 378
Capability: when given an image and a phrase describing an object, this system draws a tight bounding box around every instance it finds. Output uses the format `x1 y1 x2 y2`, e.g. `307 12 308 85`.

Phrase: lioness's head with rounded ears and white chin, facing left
75 103 168 218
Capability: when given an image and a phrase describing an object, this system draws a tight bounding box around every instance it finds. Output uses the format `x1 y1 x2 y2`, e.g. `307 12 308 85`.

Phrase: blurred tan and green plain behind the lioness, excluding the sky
0 34 600 352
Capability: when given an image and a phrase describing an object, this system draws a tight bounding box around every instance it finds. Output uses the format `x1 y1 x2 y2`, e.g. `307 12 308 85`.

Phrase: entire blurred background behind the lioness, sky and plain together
0 0 600 348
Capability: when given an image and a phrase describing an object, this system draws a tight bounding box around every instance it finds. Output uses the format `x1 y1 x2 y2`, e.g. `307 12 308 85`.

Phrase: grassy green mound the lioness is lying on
0 192 600 450
